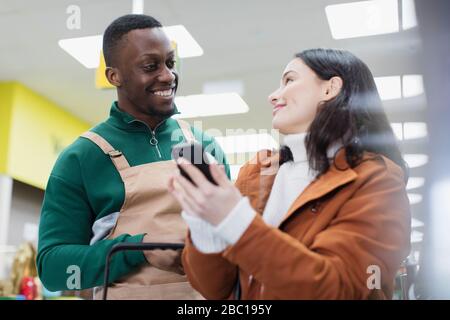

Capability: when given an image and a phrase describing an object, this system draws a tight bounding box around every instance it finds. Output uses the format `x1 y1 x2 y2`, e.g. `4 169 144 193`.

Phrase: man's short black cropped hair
103 14 162 66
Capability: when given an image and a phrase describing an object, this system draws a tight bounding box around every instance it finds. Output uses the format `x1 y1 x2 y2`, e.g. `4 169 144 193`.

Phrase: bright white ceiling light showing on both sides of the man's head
58 25 203 69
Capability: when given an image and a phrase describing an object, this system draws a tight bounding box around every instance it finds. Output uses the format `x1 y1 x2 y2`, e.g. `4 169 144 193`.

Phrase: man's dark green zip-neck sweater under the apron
36 102 230 291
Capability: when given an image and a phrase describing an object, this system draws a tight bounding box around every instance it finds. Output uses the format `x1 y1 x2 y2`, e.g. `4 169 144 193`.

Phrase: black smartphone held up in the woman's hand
172 142 217 185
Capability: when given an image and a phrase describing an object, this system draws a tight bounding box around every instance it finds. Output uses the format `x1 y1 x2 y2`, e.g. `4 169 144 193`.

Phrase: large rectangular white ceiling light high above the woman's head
325 0 399 39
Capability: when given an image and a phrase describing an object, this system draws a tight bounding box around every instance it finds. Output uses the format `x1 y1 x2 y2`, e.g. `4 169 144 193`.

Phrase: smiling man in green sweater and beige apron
37 15 229 299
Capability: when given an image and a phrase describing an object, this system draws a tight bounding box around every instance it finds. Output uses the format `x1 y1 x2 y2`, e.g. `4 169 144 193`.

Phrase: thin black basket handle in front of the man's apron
102 242 184 300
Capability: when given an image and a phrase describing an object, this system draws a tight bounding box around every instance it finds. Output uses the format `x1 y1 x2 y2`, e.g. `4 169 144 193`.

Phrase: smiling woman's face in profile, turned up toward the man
269 58 329 134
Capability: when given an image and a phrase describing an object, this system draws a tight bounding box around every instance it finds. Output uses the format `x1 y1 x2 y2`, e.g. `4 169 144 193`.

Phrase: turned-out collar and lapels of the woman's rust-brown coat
243 148 358 225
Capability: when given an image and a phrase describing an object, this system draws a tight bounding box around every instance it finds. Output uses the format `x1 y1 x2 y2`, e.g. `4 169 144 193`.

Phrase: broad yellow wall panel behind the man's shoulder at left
2 83 90 189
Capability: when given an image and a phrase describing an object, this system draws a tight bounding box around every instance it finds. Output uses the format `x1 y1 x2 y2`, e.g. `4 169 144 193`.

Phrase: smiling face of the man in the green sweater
116 28 178 117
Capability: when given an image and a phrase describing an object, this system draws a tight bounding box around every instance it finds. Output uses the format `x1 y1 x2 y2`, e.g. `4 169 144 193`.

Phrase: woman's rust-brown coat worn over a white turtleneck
182 149 411 299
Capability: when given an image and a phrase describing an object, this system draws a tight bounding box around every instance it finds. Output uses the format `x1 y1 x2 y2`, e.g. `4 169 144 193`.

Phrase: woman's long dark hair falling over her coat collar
281 49 408 179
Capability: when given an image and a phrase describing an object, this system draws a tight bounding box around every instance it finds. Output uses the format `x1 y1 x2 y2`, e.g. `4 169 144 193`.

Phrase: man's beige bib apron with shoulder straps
82 120 204 300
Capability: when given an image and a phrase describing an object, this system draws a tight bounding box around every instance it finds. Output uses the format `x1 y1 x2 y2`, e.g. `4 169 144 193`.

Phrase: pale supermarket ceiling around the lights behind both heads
0 0 424 130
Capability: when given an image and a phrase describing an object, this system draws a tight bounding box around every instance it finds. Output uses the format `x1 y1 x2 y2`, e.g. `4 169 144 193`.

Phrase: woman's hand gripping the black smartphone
169 158 242 225
